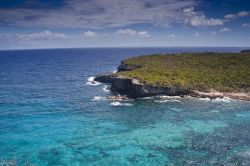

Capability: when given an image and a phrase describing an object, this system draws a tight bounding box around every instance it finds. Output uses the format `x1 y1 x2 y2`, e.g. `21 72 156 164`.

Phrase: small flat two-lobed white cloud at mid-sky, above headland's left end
115 29 151 38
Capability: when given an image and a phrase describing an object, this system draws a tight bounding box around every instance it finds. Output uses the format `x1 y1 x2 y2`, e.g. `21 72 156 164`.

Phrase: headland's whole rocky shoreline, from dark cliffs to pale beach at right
94 59 250 101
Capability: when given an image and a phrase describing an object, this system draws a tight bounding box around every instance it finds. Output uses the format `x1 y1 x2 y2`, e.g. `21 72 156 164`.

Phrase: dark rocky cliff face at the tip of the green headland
95 75 190 98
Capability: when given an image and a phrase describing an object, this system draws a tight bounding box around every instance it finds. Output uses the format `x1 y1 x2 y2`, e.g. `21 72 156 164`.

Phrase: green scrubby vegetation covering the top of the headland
115 52 250 92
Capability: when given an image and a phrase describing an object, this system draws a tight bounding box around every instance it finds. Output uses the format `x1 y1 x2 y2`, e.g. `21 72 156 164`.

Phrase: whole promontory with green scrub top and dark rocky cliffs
95 51 250 100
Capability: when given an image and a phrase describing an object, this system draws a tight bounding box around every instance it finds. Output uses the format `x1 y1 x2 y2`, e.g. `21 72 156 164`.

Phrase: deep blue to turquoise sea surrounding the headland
0 48 250 166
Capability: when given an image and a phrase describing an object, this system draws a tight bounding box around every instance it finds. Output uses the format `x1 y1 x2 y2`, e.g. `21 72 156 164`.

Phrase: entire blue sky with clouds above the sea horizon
0 0 250 50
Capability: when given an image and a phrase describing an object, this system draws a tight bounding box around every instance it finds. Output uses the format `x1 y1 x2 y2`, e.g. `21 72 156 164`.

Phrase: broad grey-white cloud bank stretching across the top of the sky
0 0 223 28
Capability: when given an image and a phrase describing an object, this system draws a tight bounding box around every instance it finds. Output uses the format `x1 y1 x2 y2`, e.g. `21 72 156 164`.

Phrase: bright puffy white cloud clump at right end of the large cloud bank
183 7 223 27
